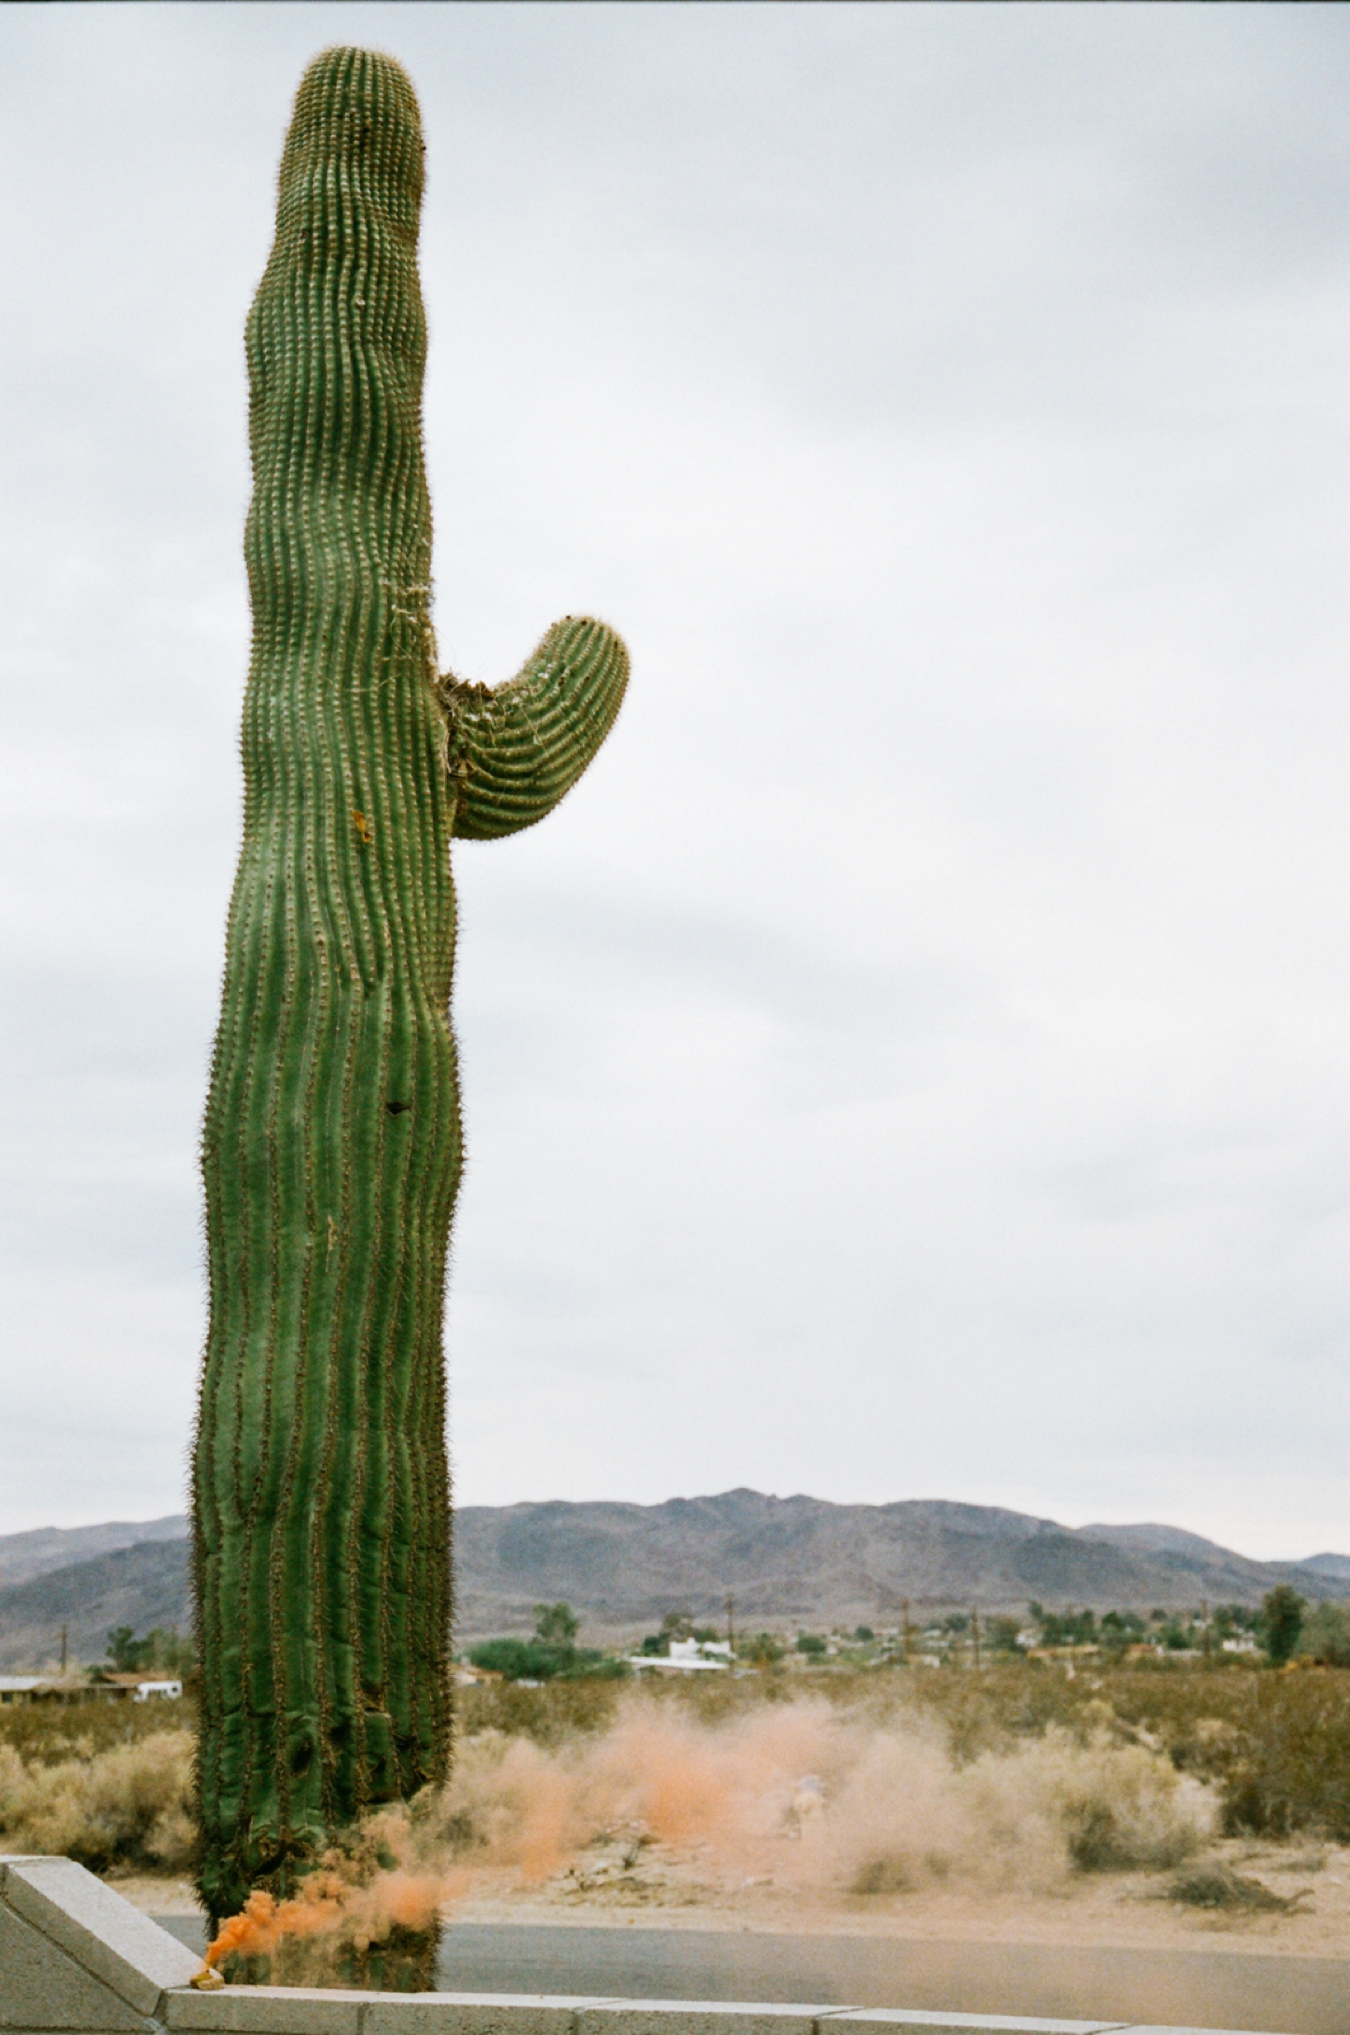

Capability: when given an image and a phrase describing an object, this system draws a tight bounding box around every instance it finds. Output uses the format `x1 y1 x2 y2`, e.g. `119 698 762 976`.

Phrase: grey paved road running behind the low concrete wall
150 1915 1350 2035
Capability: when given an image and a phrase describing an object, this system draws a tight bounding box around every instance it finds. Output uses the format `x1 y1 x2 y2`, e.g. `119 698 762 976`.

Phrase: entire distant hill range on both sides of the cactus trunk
0 1490 1350 1673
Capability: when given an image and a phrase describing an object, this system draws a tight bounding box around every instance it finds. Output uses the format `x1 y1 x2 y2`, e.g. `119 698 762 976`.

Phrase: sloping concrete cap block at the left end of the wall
0 1858 202 2015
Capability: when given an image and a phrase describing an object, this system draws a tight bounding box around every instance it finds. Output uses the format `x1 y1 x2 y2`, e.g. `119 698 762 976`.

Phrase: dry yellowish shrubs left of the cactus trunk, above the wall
0 1730 195 1872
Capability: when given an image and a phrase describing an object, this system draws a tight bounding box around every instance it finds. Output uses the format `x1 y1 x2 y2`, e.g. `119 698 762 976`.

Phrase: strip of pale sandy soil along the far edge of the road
112 1840 1350 1958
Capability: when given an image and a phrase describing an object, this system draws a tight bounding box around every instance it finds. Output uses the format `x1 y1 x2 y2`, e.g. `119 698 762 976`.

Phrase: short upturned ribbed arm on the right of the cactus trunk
442 615 629 840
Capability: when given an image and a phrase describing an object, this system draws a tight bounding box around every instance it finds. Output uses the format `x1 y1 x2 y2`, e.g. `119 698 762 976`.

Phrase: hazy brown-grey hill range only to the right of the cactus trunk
456 1490 1350 1634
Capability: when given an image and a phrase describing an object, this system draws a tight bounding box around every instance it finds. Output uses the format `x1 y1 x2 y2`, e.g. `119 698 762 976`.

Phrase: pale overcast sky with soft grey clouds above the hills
0 4 1350 1557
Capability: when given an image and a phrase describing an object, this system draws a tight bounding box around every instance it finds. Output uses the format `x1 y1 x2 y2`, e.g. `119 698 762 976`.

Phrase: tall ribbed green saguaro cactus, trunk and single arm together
193 49 627 1953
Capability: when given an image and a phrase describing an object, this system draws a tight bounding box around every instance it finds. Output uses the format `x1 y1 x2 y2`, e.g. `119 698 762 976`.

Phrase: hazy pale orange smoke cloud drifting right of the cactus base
421 1691 1216 1899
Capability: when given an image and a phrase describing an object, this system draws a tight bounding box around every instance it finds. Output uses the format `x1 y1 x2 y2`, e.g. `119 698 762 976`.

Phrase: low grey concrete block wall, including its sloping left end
0 1858 1262 2035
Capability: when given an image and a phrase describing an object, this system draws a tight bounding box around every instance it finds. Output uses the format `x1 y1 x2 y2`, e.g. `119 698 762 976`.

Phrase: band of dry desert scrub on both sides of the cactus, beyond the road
0 1661 1350 1895
